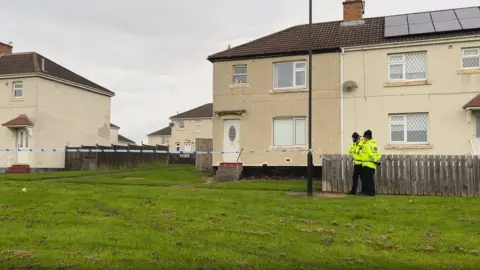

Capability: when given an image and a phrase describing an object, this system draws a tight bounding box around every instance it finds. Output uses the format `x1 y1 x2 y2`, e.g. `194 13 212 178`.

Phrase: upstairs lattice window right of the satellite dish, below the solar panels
388 52 427 81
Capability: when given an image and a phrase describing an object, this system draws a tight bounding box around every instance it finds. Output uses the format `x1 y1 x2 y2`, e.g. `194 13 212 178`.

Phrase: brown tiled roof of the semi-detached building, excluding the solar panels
208 9 480 62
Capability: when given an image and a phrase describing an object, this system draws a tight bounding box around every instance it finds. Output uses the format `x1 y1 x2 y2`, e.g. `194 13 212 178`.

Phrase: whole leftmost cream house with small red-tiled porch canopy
0 43 114 172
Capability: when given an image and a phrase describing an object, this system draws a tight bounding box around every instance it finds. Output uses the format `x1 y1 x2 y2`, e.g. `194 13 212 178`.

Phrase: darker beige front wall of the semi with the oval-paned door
213 53 340 166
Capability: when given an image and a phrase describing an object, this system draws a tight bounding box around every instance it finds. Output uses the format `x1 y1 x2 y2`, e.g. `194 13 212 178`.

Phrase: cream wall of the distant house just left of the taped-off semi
169 118 213 151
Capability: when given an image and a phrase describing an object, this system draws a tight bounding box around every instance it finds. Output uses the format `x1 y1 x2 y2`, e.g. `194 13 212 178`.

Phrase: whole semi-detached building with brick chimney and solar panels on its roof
208 0 480 174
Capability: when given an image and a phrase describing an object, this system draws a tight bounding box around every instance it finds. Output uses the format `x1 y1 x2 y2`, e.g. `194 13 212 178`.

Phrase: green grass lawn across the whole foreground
0 167 480 269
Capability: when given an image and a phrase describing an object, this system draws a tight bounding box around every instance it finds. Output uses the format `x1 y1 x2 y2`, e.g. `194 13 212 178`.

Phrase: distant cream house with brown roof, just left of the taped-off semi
169 103 213 152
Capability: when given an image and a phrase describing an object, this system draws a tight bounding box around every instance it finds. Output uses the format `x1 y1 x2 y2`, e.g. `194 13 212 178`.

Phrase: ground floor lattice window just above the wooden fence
390 113 428 144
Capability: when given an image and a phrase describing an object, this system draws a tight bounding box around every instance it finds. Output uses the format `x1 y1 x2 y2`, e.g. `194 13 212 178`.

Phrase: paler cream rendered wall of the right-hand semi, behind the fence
344 41 480 154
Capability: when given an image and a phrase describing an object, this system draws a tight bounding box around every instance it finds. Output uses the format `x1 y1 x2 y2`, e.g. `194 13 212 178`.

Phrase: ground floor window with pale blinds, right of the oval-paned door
273 118 307 146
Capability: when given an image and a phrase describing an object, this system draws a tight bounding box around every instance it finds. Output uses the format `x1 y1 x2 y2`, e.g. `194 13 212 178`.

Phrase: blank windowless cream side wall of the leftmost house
33 78 111 168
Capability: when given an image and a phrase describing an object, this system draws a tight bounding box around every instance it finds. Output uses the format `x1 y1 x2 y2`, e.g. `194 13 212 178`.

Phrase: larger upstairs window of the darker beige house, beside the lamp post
273 61 307 89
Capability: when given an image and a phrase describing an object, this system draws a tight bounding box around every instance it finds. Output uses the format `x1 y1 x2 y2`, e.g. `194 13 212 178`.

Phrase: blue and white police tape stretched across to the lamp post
0 148 308 155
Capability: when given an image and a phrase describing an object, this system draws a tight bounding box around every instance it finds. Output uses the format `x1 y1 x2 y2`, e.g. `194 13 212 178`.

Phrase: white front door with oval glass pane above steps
223 119 240 162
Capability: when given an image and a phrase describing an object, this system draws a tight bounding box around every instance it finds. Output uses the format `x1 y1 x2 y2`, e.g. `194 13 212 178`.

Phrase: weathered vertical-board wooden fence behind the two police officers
322 155 480 196
